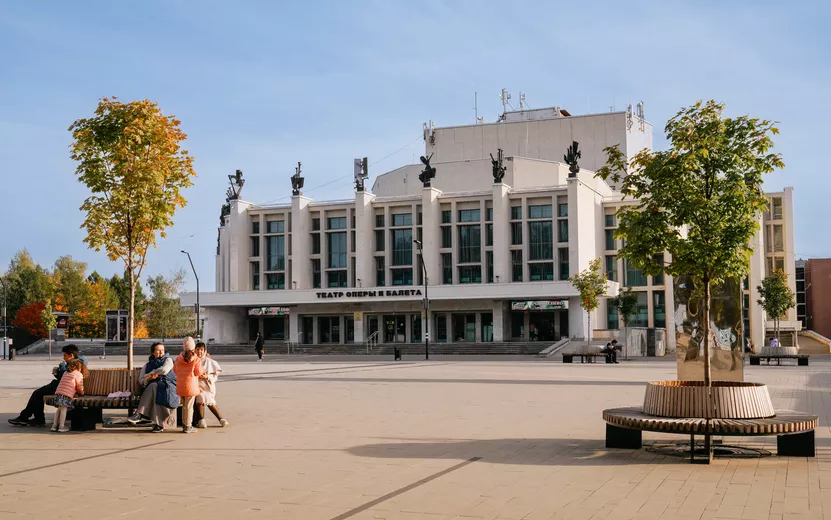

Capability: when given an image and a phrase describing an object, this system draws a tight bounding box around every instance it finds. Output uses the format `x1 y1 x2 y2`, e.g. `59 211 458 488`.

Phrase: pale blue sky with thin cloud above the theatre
0 0 831 291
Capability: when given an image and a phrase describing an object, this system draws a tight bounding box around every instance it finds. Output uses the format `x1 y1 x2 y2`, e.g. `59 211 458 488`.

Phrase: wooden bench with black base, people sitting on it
43 368 142 431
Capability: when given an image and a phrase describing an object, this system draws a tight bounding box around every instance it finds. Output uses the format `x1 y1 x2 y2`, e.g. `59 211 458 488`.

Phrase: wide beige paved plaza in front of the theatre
0 356 831 520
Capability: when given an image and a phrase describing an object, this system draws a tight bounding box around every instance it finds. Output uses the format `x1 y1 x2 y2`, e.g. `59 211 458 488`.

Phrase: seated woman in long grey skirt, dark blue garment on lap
127 343 179 433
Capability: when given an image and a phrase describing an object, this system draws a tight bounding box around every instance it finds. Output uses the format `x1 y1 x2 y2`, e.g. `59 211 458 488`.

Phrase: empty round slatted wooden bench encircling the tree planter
603 407 818 460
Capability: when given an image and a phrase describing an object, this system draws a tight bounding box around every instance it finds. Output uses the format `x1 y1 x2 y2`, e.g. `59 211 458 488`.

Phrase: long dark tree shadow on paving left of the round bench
346 439 683 466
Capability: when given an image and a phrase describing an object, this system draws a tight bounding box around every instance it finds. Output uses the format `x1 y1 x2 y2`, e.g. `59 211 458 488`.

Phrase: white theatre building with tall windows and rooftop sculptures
183 101 796 351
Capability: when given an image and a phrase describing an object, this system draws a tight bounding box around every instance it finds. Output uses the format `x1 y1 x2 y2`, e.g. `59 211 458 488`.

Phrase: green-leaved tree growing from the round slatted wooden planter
596 101 784 387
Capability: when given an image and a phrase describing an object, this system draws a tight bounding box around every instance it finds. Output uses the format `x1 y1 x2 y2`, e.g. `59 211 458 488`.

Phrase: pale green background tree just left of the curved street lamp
147 269 193 339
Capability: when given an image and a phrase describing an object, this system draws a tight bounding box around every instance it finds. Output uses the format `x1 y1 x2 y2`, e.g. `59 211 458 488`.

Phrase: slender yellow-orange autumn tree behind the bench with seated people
69 98 196 368
